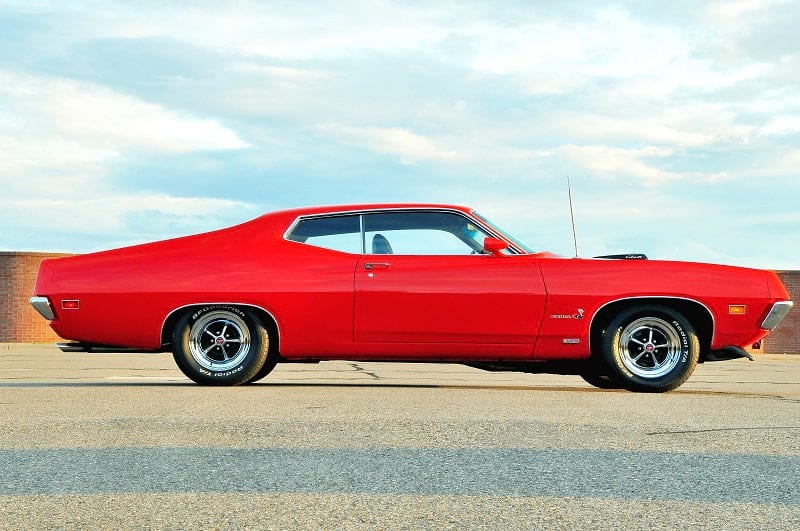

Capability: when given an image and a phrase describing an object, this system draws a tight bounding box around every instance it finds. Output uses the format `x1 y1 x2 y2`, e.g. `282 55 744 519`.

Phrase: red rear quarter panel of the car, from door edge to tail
36 214 355 350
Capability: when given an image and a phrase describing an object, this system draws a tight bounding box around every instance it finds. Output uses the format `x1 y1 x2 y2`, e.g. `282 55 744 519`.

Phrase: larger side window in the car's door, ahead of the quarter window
364 212 486 255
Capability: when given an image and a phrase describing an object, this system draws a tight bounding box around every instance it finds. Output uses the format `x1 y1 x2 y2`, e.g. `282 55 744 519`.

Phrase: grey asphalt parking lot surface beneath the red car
0 345 800 529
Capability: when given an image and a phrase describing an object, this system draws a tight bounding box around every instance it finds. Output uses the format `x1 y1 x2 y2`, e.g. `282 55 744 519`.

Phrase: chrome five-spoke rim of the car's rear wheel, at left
189 312 250 372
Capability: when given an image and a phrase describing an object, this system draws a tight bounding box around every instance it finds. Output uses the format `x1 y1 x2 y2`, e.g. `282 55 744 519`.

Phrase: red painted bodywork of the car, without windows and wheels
35 204 788 360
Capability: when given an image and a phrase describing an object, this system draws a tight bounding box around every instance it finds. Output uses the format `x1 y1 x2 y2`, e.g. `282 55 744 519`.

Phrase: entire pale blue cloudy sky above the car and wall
0 0 800 269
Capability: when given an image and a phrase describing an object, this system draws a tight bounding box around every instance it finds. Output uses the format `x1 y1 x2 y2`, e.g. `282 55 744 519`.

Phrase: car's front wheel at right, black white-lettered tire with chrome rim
601 305 700 393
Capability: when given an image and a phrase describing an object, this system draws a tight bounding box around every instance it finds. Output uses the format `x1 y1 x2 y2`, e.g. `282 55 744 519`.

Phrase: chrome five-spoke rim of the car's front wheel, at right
619 317 681 379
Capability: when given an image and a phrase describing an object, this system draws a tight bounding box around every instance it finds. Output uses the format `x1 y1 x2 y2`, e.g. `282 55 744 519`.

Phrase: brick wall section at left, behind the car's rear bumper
0 252 72 343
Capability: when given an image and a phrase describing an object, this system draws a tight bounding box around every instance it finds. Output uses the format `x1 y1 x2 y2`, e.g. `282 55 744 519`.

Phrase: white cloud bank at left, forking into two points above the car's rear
0 70 252 250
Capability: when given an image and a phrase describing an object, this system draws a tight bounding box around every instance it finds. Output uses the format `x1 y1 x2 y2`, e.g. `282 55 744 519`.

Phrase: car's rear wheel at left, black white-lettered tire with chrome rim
172 304 269 385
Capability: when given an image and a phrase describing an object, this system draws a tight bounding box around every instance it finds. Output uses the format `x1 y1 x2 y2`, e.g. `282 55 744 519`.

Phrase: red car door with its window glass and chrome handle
354 211 545 358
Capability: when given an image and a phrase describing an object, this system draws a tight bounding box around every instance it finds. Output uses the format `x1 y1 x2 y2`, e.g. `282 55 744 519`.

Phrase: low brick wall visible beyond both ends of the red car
0 252 800 354
